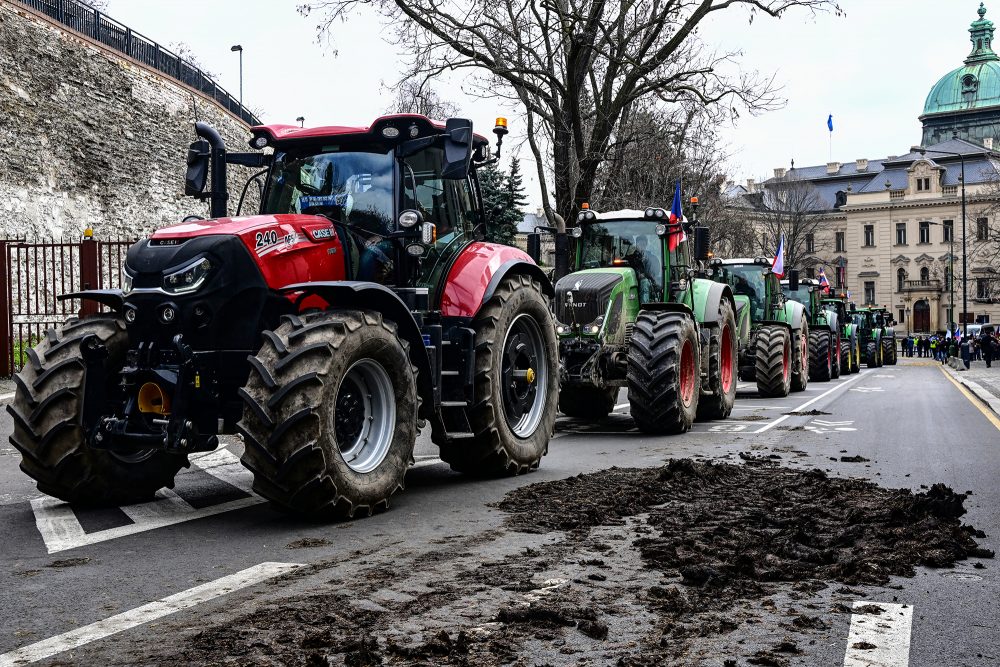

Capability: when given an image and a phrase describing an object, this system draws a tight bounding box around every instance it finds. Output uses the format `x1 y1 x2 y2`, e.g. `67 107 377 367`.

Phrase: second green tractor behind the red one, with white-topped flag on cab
708 257 809 397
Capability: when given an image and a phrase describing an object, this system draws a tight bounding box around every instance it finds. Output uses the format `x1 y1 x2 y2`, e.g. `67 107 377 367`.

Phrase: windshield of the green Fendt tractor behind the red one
579 220 664 303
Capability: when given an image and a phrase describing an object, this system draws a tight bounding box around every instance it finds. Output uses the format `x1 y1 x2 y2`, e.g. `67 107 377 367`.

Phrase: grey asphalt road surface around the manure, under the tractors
0 360 1000 667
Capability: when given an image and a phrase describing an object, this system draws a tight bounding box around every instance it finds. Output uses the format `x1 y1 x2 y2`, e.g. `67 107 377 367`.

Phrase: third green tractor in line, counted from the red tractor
781 271 842 382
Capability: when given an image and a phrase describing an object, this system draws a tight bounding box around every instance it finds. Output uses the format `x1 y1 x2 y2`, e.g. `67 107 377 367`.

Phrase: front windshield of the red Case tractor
261 146 394 234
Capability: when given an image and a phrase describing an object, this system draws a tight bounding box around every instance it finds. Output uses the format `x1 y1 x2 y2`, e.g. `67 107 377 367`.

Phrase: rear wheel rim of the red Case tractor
500 313 549 438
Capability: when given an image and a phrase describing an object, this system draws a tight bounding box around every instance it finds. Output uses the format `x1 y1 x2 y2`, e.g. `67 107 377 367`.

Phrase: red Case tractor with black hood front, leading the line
8 115 559 517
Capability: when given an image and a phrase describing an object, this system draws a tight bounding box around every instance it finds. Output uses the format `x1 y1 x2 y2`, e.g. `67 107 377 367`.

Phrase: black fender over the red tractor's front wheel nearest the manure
278 280 434 419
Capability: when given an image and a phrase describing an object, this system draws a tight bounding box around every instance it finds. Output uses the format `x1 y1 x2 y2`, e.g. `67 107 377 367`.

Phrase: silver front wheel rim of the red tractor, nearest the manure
334 359 396 473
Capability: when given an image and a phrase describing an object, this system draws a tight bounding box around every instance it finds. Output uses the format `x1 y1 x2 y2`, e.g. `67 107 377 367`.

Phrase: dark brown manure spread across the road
132 459 992 667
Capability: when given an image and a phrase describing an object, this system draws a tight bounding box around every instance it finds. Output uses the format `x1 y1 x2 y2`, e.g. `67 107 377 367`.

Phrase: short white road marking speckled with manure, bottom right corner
844 601 913 667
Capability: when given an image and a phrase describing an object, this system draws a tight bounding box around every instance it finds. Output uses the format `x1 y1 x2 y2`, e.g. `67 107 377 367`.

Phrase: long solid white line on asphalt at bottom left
0 563 303 667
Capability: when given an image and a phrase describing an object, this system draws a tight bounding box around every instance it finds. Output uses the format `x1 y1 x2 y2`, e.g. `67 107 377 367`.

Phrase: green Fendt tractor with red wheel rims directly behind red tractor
554 208 736 433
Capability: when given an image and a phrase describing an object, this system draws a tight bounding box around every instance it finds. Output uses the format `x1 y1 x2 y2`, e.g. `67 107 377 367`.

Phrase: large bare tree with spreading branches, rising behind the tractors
300 0 841 230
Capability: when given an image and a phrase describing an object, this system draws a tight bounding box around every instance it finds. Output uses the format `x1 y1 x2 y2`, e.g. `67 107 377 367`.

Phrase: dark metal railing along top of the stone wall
16 0 261 125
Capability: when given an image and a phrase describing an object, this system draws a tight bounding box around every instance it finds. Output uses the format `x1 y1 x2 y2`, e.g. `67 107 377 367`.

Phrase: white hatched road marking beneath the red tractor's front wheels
31 449 264 554
